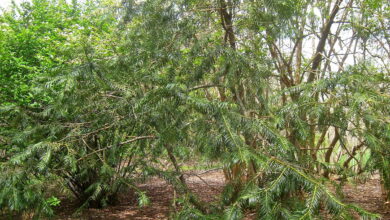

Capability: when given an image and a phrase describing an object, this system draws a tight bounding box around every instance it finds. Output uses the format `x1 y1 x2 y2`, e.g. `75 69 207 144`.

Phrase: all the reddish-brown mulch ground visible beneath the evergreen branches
57 170 390 220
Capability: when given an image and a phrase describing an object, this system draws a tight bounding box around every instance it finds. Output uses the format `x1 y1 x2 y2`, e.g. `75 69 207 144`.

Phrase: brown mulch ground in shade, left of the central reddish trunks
57 170 224 220
